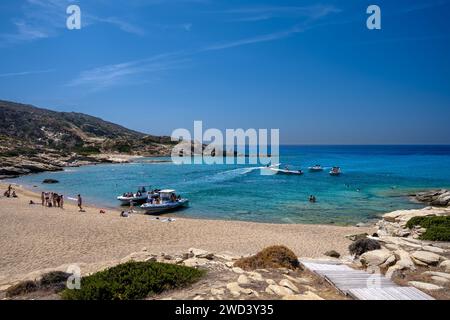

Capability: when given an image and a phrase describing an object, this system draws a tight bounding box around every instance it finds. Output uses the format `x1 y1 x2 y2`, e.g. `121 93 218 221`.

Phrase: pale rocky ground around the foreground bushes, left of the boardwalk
0 248 345 300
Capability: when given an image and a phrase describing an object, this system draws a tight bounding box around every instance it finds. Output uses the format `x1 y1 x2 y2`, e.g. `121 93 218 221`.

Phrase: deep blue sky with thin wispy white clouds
0 0 450 144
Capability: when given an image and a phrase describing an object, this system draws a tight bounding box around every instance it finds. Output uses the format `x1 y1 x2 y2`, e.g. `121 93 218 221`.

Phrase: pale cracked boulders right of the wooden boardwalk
348 206 450 298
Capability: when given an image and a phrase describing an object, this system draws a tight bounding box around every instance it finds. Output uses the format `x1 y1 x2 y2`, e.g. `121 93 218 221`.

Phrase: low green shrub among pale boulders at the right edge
406 216 450 241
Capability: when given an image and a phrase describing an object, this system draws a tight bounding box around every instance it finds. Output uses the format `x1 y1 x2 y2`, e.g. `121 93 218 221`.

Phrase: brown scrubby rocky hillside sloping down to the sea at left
0 100 178 178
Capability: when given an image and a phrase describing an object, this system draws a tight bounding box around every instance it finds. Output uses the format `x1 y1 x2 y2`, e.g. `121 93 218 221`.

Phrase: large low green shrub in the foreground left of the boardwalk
61 262 205 300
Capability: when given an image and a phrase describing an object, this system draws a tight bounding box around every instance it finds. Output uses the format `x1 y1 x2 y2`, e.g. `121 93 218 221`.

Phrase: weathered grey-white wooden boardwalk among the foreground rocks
300 259 434 300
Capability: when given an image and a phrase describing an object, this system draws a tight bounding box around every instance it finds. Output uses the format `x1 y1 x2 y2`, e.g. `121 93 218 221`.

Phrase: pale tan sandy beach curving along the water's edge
0 184 374 282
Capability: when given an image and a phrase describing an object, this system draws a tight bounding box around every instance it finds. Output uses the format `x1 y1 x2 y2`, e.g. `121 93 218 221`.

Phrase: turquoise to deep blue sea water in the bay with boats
8 146 450 224
